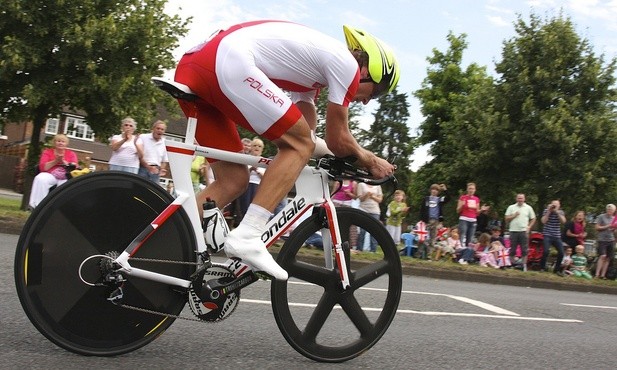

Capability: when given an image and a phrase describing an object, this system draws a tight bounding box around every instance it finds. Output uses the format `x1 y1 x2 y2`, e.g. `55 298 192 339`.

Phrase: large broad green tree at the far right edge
491 14 617 213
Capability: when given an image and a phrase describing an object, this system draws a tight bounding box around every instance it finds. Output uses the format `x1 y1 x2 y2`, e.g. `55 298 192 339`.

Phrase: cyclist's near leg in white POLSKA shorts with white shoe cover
175 48 314 279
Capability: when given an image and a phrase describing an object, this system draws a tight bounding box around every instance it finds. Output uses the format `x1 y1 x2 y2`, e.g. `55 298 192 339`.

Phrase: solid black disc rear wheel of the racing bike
14 171 196 356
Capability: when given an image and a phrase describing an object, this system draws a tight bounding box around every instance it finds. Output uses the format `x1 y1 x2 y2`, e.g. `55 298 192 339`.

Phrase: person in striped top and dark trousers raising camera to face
540 200 566 274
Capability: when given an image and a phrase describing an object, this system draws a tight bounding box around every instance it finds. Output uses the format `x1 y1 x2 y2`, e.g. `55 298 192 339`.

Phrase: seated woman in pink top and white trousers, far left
28 134 77 209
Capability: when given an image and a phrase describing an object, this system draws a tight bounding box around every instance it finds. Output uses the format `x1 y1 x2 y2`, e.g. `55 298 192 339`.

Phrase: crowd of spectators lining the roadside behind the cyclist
29 117 617 279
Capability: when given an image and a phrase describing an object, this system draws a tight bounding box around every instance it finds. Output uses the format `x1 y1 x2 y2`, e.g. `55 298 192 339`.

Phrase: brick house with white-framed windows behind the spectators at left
0 109 186 193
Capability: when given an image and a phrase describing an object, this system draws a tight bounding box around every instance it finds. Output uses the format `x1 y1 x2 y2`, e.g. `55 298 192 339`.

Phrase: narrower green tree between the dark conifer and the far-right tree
408 32 494 219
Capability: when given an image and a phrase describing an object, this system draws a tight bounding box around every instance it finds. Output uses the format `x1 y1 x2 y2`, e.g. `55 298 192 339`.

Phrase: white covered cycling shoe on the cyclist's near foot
225 226 288 280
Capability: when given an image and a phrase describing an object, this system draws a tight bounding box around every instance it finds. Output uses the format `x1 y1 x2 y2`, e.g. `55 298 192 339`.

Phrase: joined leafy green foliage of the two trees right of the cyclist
413 14 617 224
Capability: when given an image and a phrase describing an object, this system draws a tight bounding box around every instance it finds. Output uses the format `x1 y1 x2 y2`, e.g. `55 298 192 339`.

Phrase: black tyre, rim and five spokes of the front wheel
271 207 402 362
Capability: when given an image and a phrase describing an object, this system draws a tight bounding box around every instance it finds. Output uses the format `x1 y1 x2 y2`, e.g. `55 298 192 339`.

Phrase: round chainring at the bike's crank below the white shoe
188 264 240 322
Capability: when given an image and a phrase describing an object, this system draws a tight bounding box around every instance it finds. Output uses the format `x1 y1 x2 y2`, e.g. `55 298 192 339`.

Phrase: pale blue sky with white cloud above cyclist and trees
166 0 617 169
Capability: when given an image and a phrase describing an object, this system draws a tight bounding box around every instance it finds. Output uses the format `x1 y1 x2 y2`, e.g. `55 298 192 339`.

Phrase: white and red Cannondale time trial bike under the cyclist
15 79 402 362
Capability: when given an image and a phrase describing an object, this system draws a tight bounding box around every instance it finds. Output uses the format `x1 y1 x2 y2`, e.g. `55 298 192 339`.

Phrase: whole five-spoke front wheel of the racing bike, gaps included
272 208 402 362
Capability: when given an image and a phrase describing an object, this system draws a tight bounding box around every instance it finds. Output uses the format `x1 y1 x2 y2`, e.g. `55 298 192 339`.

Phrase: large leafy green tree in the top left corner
0 0 188 208
